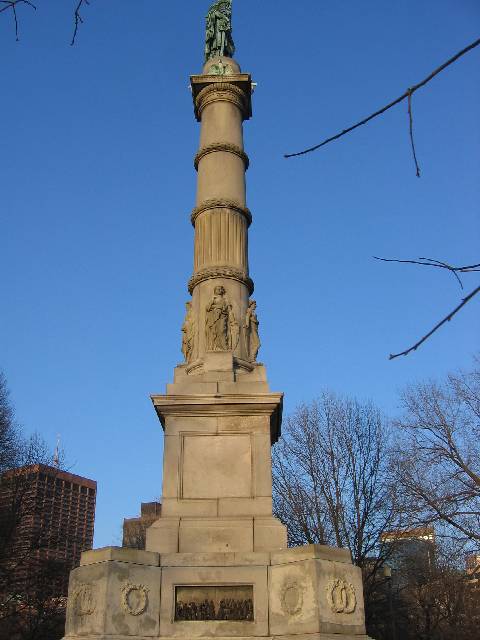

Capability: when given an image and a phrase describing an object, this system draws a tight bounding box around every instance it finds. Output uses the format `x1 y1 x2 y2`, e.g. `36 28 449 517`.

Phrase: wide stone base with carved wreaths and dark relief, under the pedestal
65 545 374 640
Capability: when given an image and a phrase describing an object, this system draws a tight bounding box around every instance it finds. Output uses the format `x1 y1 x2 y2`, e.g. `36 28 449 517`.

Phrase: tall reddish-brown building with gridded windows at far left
0 464 97 597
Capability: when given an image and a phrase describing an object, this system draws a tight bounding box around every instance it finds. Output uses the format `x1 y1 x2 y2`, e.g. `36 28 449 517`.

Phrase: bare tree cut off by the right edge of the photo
397 357 480 548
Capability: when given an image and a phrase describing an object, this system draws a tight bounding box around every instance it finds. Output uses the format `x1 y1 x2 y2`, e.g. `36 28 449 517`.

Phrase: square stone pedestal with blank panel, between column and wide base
147 384 287 553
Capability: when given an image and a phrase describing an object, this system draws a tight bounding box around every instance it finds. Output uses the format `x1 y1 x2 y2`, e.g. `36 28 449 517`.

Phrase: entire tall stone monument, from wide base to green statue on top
65 0 374 640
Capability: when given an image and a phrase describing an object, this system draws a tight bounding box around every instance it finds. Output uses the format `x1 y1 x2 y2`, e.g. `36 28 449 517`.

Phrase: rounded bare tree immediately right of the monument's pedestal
273 392 401 626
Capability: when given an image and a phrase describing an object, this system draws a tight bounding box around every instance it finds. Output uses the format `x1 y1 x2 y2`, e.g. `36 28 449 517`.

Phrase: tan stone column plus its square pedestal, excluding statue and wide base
147 58 287 553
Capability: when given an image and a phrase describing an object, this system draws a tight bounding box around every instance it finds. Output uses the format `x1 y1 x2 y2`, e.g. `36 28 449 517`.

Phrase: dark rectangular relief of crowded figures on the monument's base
175 585 254 622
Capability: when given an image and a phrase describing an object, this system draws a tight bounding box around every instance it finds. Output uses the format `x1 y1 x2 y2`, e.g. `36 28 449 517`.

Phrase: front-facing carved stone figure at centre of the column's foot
205 285 239 351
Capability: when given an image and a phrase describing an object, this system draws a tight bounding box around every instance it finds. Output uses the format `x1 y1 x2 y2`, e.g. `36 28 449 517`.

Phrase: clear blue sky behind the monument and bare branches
0 0 480 546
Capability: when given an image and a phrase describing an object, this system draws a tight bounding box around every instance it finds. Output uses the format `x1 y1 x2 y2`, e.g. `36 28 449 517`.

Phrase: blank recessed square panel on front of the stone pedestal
182 434 252 500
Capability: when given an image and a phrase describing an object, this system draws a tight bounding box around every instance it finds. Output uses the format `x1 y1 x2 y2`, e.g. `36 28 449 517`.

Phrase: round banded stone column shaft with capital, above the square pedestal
189 58 253 373
